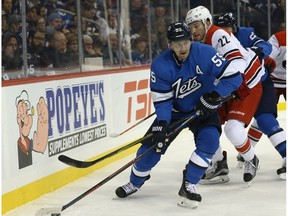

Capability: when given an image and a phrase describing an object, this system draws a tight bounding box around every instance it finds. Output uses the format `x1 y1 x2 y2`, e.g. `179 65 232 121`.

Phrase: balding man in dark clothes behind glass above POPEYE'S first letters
43 31 79 69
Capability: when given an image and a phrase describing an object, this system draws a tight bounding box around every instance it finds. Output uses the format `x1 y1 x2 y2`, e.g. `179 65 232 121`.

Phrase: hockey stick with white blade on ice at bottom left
35 111 201 216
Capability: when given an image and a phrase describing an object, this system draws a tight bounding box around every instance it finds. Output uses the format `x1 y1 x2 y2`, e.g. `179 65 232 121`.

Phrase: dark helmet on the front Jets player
167 21 191 42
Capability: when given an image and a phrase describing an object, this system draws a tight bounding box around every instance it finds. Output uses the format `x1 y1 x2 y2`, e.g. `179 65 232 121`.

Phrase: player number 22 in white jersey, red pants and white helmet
186 6 265 184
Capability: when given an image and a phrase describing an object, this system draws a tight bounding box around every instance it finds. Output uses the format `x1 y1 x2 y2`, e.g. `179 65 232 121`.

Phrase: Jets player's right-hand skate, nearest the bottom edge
178 180 202 209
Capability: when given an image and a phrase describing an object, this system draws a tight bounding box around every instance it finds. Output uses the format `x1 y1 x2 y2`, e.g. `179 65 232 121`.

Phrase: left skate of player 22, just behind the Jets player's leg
200 151 230 185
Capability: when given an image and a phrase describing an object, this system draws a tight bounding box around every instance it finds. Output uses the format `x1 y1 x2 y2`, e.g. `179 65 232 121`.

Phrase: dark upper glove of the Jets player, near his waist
196 91 222 118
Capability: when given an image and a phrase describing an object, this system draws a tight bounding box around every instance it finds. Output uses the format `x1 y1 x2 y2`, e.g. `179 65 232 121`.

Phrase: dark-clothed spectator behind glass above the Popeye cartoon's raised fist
27 30 45 70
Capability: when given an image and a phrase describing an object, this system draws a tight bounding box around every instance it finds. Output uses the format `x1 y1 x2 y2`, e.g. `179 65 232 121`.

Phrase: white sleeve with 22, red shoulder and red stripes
206 25 265 88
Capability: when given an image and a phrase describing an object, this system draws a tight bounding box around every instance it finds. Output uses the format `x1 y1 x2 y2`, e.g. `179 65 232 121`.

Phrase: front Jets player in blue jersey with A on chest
115 22 242 208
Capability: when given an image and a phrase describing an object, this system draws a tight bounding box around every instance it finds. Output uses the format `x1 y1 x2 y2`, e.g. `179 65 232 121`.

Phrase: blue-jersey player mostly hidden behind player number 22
206 12 286 183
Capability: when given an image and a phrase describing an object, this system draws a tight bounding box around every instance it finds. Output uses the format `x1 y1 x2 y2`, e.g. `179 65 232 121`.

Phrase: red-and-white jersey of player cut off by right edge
268 31 287 88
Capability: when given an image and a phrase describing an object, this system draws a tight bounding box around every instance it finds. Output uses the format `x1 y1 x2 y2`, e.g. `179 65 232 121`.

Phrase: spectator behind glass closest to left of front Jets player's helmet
131 37 149 65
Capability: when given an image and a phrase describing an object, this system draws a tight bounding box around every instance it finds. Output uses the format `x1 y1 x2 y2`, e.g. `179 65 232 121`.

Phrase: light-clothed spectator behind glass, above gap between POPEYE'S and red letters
103 33 132 67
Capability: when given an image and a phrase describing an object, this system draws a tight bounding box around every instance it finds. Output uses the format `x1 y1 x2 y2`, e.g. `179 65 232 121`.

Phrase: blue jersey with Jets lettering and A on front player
150 42 242 123
